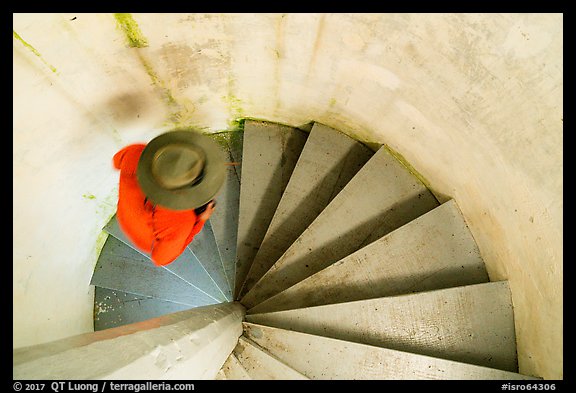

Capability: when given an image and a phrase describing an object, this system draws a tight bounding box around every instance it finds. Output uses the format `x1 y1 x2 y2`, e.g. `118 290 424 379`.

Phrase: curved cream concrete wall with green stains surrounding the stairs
13 14 563 378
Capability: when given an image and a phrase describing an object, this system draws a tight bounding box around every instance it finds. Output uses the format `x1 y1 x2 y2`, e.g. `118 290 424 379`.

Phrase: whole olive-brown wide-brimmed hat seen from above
136 131 226 210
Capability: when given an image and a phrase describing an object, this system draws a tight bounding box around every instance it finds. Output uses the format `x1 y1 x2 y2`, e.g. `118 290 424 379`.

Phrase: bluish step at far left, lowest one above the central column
94 287 190 331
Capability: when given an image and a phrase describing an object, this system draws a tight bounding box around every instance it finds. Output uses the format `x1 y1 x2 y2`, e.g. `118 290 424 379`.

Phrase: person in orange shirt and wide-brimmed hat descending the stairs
113 131 225 266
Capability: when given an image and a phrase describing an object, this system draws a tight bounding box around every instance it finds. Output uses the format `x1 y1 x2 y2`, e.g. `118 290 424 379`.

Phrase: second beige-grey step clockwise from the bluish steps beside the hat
240 123 374 297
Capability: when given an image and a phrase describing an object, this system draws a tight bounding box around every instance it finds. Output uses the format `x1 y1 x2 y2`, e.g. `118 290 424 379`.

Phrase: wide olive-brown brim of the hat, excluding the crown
136 131 226 210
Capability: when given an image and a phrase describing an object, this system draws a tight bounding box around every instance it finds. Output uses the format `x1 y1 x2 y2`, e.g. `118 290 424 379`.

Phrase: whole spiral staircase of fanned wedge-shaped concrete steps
91 120 534 380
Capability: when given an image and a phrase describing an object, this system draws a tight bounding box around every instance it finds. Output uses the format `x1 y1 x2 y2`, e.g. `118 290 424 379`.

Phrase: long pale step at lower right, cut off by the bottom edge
243 322 535 380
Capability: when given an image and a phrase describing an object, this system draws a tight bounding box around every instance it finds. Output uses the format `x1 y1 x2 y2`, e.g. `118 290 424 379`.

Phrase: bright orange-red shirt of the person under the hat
113 144 204 266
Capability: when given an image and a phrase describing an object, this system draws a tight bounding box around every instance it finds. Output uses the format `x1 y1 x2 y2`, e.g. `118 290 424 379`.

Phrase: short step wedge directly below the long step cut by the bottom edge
232 336 308 380
